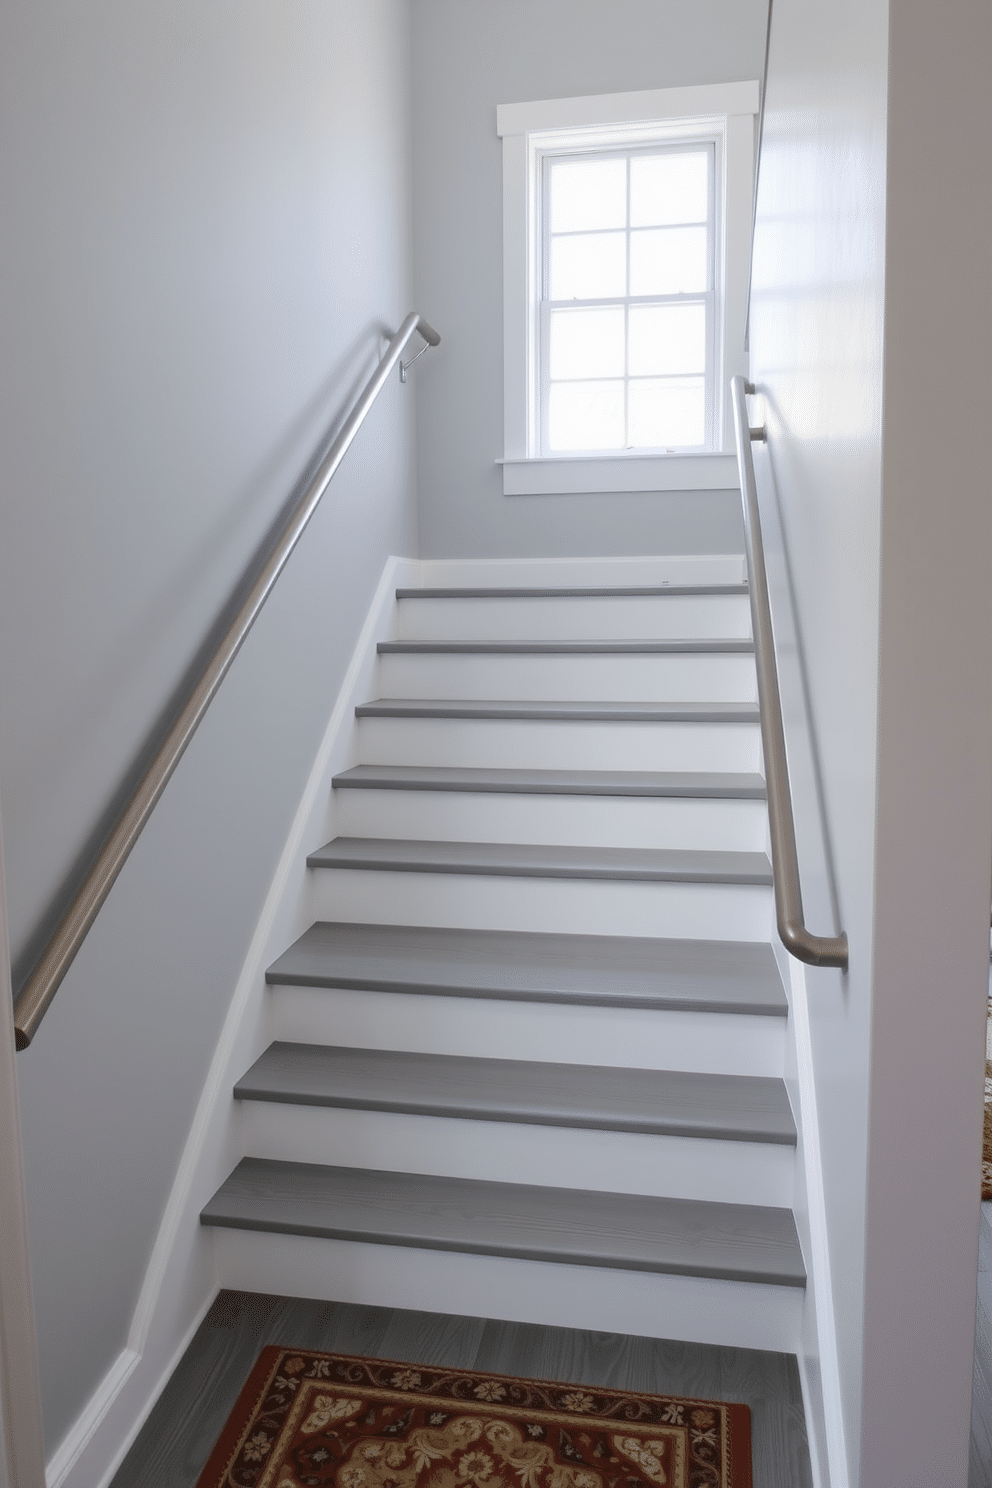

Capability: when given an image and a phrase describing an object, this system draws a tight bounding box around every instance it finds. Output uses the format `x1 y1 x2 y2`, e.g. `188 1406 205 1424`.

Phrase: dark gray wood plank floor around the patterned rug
112 1292 812 1488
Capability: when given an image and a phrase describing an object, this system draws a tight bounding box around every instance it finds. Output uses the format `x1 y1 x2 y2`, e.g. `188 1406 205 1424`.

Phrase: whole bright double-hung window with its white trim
497 82 759 494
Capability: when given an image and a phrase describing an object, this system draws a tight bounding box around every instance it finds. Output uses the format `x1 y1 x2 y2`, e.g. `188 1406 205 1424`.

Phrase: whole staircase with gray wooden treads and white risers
201 559 805 1351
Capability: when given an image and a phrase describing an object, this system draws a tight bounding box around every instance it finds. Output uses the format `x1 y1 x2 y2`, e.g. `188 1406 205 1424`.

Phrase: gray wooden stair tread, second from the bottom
235 1043 796 1146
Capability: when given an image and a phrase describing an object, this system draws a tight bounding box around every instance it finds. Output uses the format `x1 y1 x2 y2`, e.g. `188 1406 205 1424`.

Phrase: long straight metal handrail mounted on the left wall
13 312 440 1049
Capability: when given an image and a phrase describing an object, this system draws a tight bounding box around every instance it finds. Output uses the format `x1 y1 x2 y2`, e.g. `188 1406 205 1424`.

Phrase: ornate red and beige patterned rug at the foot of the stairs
196 1347 751 1488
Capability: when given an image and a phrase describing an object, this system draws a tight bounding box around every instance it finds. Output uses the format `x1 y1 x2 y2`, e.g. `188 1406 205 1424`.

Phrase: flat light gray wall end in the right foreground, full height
861 0 992 1488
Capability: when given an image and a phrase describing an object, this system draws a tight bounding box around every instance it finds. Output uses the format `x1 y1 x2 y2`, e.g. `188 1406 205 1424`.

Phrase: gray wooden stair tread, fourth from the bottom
306 836 772 884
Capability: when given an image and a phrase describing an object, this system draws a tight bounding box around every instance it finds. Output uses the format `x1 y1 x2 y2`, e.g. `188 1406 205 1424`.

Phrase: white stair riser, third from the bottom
269 987 785 1079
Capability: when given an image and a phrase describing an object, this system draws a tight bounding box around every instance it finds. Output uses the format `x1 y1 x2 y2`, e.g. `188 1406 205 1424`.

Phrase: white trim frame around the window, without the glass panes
497 82 759 496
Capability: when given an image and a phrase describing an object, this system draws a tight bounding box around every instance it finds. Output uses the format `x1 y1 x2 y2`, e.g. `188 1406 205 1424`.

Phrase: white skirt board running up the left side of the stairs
48 558 419 1488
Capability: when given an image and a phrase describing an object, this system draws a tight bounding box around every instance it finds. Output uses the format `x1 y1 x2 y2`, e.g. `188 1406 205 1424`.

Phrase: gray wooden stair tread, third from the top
355 698 759 723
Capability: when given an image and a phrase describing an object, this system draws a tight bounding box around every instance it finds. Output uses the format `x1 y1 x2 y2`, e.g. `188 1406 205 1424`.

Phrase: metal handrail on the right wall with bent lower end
730 376 848 972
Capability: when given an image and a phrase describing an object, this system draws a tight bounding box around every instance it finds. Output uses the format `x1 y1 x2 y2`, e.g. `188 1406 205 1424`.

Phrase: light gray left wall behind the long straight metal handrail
0 0 416 1443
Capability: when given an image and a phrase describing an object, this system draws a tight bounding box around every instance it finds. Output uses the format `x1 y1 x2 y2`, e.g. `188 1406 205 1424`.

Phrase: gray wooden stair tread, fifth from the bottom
332 765 764 801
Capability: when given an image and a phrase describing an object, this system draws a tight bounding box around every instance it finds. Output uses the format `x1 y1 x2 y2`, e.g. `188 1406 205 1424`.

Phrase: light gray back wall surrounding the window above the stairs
412 0 766 557
